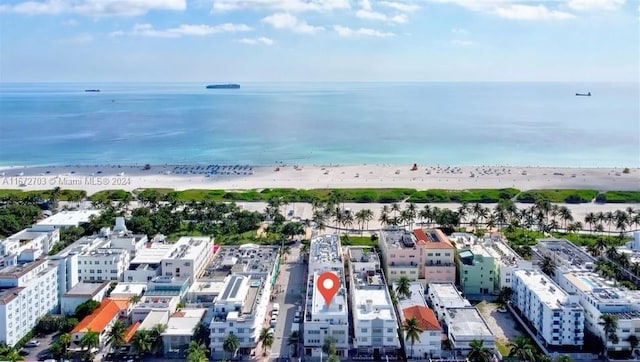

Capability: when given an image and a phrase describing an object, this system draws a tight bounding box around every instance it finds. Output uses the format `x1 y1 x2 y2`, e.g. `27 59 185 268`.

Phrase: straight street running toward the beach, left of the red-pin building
269 244 307 361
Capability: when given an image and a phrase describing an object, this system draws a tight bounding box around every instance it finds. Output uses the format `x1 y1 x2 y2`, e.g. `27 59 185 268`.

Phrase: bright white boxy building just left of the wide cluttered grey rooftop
160 236 213 281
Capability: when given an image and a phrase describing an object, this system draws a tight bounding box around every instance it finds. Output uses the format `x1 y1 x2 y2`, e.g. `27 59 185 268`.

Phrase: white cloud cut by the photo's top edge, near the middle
212 0 351 12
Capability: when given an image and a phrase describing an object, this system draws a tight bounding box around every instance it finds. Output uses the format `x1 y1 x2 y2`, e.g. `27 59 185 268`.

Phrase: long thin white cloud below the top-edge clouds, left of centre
129 23 251 38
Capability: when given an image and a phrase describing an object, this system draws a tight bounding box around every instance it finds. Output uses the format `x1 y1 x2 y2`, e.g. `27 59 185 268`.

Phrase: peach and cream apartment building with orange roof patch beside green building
379 229 456 285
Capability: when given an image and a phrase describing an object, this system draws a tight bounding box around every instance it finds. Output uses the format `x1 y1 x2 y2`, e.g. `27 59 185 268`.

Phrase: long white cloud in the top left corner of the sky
0 0 187 16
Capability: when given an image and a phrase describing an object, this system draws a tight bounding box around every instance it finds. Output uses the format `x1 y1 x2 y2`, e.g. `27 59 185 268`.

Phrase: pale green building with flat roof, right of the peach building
457 244 500 295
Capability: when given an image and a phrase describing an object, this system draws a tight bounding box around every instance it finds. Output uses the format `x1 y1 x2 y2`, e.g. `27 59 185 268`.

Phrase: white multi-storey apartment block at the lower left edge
0 259 59 346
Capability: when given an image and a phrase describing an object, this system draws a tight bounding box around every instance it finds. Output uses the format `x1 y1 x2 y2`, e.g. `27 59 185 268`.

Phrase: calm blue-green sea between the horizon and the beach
0 82 640 167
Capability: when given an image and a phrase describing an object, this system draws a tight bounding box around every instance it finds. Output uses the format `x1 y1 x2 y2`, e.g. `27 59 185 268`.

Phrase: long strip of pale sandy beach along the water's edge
0 164 640 194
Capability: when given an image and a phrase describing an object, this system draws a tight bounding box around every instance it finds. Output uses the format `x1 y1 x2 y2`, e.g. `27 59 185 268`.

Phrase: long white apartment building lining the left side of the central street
206 244 279 359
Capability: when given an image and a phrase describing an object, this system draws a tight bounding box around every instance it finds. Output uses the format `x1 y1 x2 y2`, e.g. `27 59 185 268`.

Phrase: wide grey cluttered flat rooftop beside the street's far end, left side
200 244 280 280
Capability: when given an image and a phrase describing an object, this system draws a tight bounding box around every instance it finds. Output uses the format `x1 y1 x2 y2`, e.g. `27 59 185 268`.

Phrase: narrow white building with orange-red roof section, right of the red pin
394 282 442 360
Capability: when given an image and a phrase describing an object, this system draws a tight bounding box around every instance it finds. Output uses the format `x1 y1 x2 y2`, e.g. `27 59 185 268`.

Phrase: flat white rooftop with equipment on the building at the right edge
564 272 640 306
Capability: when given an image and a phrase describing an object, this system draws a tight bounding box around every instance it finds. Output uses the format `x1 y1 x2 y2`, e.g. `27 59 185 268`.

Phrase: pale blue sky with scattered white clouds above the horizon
0 0 640 82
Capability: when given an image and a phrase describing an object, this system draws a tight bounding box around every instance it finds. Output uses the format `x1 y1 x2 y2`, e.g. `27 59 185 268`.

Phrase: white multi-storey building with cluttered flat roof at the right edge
558 271 640 351
